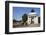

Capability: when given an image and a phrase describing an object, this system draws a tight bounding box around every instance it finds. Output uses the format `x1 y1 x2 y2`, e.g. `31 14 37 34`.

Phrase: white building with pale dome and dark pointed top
27 10 39 25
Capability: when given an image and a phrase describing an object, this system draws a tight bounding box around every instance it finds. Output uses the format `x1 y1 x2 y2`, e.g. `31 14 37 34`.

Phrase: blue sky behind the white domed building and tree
13 7 40 20
